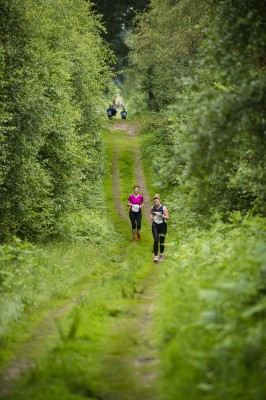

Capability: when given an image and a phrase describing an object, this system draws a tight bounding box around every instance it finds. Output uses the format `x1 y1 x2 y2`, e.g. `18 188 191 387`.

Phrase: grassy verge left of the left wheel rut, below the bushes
0 242 120 366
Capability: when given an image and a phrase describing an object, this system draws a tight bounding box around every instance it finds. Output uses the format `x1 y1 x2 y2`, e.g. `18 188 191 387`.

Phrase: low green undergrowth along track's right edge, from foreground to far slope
139 116 266 400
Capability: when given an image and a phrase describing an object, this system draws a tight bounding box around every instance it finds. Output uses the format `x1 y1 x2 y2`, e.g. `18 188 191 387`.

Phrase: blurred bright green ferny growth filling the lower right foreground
156 213 266 400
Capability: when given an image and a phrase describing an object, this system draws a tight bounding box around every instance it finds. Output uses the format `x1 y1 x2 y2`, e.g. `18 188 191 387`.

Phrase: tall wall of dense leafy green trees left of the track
0 0 110 239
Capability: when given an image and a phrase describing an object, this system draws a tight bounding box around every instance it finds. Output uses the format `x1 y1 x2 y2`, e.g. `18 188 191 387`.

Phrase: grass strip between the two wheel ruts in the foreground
5 244 154 399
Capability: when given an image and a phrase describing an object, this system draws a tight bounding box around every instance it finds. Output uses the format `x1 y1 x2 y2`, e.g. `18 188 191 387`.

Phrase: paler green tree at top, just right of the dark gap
130 0 207 110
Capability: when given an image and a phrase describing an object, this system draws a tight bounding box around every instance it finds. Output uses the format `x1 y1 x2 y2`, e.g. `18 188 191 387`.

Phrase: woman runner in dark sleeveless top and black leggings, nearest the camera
151 194 169 263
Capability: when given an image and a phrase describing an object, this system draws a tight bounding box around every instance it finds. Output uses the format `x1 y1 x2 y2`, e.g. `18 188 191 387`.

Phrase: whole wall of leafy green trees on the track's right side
129 0 266 220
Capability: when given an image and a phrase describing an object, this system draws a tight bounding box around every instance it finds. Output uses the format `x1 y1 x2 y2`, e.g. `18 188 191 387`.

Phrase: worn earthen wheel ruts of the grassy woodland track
0 122 159 400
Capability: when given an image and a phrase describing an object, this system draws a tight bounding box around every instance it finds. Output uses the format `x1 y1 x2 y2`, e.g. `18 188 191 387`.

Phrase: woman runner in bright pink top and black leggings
127 185 144 243
